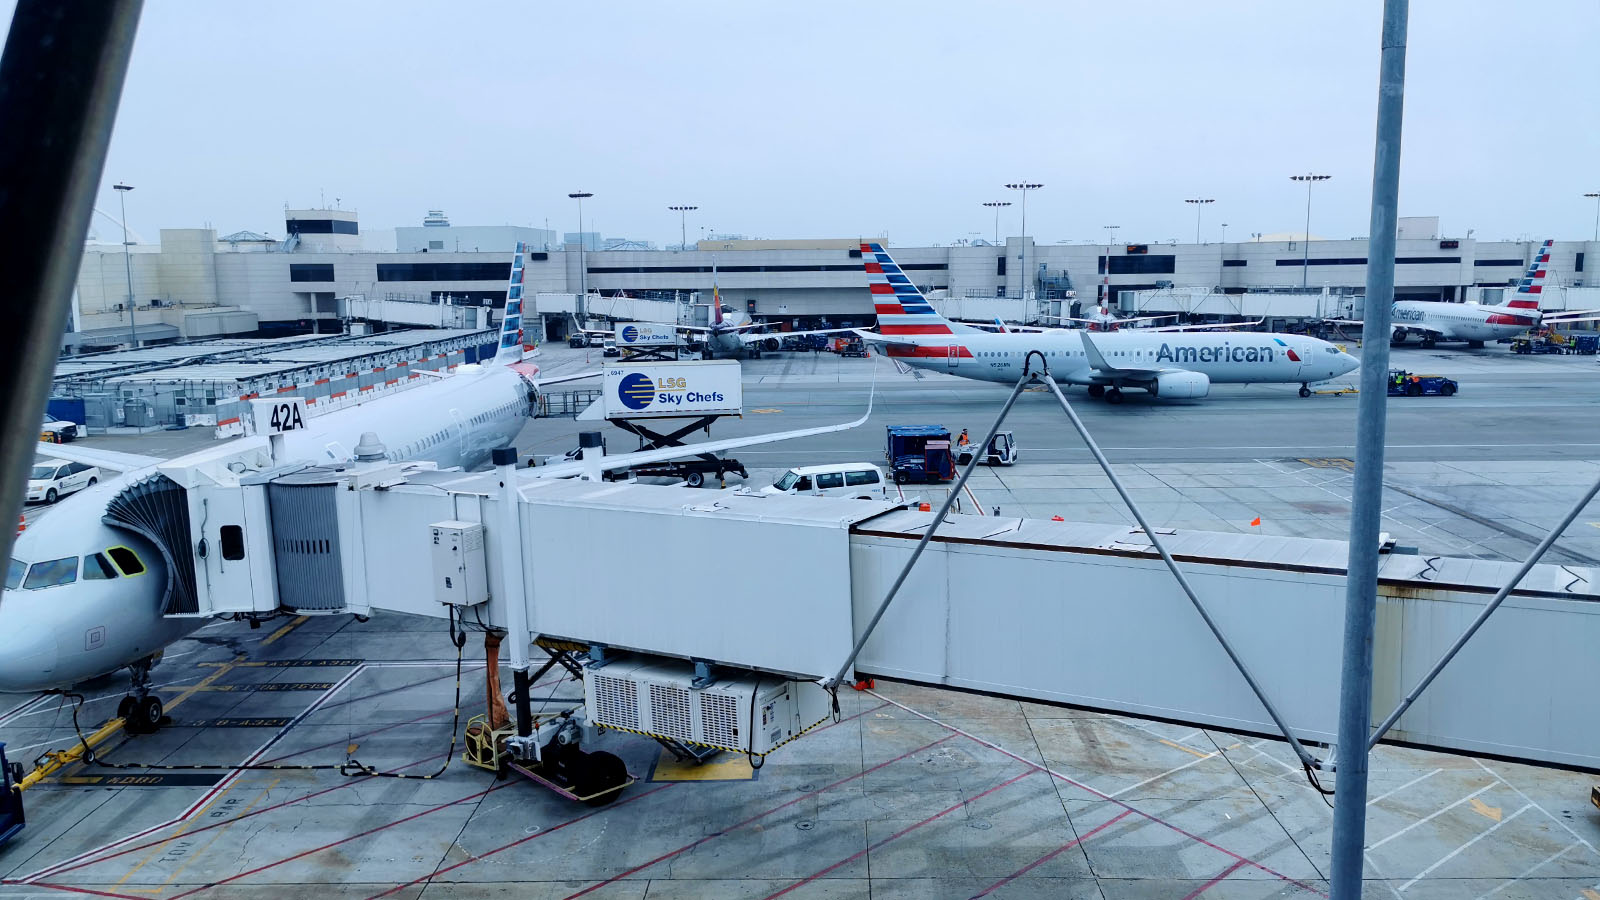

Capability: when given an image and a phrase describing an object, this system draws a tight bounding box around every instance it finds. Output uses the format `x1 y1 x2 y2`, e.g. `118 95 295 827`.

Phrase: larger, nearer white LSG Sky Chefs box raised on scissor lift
600 359 744 418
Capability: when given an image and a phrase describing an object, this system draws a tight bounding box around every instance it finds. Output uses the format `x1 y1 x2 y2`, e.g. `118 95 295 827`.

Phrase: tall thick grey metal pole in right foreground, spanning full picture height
1331 0 1408 900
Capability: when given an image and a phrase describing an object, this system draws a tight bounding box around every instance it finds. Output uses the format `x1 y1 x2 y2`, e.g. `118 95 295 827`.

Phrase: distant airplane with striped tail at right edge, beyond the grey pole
1363 240 1597 348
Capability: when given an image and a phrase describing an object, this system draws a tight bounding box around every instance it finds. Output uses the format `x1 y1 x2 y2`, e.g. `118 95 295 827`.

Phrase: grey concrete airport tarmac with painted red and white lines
12 336 1600 900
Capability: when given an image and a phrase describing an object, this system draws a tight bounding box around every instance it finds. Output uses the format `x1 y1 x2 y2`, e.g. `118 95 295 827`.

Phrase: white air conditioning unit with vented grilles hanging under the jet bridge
584 660 832 754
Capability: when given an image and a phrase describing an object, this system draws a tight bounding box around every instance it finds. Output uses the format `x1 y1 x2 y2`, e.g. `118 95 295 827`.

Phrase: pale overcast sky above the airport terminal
5 0 1600 247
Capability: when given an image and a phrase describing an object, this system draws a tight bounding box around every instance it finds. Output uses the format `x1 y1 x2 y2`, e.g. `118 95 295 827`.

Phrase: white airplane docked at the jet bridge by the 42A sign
0 245 870 732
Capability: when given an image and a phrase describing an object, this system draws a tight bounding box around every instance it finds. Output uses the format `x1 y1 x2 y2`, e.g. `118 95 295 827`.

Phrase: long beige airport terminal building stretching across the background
78 210 1600 349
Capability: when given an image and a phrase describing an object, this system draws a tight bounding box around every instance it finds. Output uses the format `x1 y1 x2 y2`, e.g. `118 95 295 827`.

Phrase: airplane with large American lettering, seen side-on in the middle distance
858 243 1360 404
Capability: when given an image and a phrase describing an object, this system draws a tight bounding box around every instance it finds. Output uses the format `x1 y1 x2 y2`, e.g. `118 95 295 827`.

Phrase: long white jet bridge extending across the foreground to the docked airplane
163 447 1600 767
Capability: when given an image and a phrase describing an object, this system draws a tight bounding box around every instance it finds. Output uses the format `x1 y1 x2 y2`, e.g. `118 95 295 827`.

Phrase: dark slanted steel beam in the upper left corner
0 0 142 570
